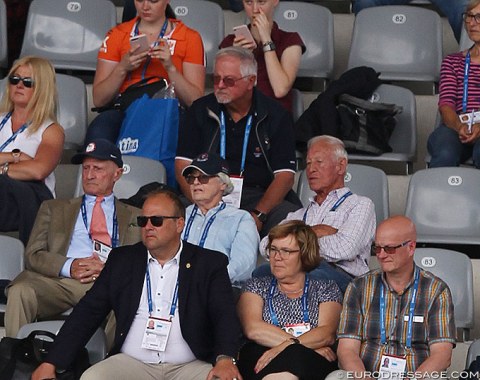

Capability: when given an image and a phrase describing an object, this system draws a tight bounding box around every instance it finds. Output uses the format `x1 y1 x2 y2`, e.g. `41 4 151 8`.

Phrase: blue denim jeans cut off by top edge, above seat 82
353 0 468 42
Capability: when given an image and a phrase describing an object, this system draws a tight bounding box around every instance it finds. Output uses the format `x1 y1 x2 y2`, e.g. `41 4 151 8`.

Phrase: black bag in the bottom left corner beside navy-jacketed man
0 330 90 380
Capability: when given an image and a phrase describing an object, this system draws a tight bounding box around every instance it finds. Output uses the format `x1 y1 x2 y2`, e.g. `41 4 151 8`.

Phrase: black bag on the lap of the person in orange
92 77 168 112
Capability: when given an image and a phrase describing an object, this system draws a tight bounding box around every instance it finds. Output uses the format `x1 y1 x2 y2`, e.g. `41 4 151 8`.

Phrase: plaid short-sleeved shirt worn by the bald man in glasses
337 266 456 371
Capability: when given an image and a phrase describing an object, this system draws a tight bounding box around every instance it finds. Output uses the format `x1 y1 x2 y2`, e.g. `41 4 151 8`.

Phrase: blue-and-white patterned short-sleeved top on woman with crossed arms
243 276 342 328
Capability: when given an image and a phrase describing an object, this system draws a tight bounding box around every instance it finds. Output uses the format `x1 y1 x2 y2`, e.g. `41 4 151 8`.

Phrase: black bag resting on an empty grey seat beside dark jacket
337 94 403 155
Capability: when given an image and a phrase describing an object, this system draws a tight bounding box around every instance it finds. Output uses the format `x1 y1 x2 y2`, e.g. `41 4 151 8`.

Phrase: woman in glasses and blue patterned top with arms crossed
238 220 342 380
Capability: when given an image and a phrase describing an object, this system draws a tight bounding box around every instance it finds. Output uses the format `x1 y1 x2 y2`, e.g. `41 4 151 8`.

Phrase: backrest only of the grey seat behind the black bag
370 84 417 157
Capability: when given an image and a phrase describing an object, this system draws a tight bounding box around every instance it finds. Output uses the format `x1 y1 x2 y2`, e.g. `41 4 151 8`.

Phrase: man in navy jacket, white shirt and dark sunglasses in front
32 190 241 380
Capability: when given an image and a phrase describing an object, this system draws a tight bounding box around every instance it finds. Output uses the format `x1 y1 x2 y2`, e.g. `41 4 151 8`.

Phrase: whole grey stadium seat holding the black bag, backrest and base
348 84 417 174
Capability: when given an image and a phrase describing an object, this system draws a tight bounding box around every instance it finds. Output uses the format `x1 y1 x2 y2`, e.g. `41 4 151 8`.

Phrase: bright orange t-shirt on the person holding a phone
98 17 205 92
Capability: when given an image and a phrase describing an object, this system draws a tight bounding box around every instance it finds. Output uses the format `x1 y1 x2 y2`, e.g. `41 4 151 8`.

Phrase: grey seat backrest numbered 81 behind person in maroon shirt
274 1 334 78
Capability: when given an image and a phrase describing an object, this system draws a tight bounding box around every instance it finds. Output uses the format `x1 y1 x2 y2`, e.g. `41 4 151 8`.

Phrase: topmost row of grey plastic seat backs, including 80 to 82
0 0 462 90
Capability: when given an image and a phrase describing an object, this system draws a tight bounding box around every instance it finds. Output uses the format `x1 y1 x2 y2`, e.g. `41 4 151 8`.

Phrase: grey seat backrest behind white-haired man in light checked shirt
297 164 389 224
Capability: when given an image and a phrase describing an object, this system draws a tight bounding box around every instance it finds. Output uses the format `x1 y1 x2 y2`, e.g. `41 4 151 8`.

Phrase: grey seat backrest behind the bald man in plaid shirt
414 248 474 329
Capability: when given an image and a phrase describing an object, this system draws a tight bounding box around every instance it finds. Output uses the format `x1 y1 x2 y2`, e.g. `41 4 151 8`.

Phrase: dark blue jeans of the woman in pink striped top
427 123 480 169
